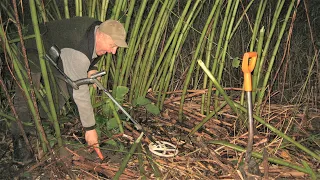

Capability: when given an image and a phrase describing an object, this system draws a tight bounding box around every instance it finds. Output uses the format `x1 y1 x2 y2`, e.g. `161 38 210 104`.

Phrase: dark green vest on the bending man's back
25 17 101 69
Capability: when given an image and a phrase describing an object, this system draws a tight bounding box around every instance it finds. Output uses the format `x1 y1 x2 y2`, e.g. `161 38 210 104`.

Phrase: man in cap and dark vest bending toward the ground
11 17 128 164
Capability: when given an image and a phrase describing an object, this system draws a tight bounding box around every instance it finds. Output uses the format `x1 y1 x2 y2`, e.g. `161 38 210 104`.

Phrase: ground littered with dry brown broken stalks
0 90 320 179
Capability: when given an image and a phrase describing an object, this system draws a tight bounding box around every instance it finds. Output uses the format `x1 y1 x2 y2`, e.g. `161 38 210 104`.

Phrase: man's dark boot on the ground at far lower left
12 136 33 166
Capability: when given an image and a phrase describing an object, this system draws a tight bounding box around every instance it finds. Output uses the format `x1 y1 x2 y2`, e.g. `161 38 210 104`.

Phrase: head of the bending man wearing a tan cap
96 20 128 56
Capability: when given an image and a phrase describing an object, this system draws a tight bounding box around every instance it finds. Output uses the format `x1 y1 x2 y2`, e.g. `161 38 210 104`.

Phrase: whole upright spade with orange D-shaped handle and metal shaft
242 52 257 163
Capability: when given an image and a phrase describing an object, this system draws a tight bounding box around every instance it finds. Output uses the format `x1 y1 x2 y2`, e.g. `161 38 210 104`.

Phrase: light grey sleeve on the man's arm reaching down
61 48 95 128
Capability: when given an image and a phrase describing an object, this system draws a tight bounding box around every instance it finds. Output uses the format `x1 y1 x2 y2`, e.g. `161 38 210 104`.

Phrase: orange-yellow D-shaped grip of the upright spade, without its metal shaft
242 52 258 92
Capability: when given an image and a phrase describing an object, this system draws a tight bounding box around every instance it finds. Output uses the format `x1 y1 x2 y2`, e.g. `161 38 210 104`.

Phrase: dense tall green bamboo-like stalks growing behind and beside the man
0 0 320 177
